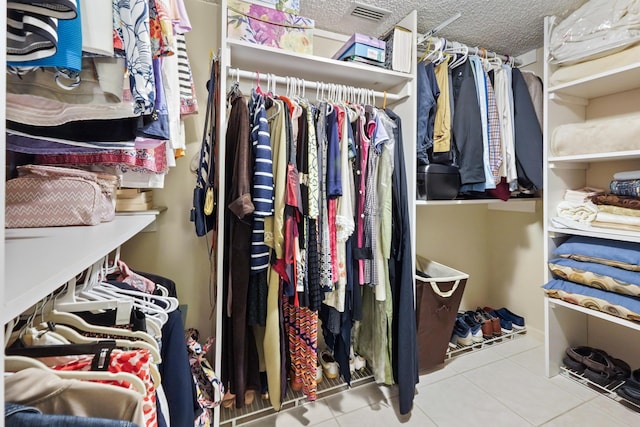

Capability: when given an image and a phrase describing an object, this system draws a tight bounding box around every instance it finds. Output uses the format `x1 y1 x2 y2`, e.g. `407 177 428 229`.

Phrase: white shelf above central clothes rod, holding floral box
227 39 413 91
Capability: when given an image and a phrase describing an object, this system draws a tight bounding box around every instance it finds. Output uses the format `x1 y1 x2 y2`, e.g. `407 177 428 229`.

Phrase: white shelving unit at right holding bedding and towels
544 17 640 377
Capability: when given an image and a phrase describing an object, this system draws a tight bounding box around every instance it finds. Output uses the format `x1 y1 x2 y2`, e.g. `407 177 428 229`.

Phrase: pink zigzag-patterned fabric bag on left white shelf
5 165 118 228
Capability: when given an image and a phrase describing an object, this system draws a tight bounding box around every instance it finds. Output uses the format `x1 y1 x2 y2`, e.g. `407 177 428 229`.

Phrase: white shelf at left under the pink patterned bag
0 214 156 324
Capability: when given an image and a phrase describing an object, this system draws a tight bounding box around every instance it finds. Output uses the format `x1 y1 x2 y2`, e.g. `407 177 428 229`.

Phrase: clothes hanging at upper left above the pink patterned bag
7 0 197 188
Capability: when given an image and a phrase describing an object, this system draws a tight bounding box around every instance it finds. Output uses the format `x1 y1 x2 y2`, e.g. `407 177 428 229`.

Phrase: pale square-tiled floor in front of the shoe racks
242 334 640 427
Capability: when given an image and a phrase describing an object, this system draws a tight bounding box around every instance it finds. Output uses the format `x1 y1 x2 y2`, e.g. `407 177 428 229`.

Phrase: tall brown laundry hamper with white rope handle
416 255 469 371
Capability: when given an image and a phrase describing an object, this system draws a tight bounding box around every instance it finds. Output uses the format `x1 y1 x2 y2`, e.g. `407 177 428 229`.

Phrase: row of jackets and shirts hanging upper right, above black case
416 55 542 200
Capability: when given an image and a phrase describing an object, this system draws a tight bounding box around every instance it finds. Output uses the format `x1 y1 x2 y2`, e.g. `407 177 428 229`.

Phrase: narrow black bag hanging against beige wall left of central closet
190 58 219 237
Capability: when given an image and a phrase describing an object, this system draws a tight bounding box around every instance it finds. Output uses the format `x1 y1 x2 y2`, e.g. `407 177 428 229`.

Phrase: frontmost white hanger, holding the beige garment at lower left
4 356 147 396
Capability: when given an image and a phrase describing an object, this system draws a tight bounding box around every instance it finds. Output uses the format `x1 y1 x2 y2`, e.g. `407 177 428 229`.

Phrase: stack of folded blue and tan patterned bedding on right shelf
543 236 640 321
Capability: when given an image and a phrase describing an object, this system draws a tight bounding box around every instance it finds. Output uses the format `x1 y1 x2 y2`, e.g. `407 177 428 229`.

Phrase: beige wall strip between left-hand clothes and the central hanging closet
122 0 220 337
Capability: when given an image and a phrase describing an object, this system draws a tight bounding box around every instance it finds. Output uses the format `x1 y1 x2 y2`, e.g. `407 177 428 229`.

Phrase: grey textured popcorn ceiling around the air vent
215 0 584 56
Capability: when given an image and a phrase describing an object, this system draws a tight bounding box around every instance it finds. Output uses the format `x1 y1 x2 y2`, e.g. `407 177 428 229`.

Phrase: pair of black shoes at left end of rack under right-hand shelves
563 346 640 391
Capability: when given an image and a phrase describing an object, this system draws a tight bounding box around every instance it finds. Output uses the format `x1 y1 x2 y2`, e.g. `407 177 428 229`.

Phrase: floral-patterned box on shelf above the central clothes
227 0 315 55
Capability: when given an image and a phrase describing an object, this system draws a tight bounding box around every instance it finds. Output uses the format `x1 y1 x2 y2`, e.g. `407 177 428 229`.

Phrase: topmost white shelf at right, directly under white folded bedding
549 62 640 99
